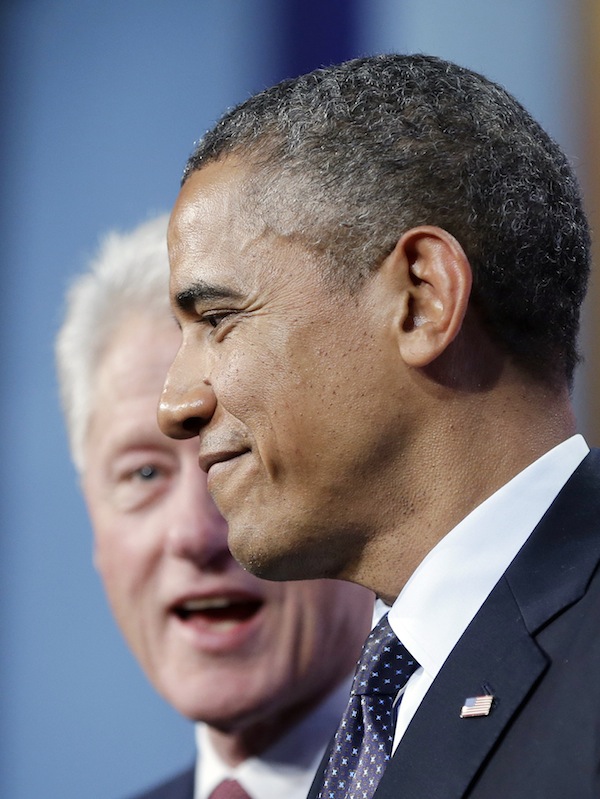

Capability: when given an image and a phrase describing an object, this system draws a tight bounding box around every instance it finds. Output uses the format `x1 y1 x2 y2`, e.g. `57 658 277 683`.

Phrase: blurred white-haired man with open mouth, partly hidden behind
57 217 372 799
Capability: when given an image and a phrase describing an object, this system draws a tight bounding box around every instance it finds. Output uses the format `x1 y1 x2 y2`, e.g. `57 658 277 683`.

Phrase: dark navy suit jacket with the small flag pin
309 451 600 799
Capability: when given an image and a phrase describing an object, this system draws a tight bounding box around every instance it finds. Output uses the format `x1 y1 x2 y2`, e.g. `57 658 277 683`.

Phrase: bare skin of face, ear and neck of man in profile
159 157 573 602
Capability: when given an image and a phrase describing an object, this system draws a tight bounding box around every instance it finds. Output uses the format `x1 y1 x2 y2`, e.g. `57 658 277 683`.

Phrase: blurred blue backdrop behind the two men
0 0 586 799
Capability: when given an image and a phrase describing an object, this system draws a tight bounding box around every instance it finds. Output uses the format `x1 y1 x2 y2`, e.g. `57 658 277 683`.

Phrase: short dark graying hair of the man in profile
184 54 590 385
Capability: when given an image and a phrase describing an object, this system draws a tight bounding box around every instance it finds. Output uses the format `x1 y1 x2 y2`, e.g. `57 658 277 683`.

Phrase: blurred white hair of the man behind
56 214 169 472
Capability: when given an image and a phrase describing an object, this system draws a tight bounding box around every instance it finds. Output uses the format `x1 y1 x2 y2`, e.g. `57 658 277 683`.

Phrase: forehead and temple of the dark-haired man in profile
168 157 340 317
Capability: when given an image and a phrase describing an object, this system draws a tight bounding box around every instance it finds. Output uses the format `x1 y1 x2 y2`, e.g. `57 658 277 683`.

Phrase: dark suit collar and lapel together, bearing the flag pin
375 454 600 799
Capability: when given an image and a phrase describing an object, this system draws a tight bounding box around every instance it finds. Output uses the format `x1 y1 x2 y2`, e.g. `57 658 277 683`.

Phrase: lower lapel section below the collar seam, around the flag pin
375 581 547 799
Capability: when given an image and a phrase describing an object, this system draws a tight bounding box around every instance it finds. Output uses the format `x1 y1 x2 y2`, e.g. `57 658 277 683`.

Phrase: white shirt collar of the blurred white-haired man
194 675 352 799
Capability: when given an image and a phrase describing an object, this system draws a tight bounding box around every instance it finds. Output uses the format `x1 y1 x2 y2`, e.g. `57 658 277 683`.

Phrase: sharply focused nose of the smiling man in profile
158 350 217 439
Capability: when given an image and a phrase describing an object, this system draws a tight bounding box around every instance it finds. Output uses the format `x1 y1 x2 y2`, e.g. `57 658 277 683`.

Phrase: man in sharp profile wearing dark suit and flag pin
159 56 600 799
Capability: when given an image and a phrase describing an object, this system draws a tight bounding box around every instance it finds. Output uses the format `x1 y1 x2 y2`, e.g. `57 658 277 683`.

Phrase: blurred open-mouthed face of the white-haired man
84 316 371 752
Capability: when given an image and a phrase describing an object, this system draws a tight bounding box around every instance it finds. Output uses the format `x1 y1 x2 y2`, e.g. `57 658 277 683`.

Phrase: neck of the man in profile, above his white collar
345 372 575 604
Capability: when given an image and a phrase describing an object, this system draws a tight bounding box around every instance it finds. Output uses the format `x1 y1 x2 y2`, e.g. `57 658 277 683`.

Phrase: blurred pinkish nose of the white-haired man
166 457 232 570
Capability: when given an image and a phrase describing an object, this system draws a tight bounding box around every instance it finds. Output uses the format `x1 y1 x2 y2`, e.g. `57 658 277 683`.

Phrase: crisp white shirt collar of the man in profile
389 435 589 749
